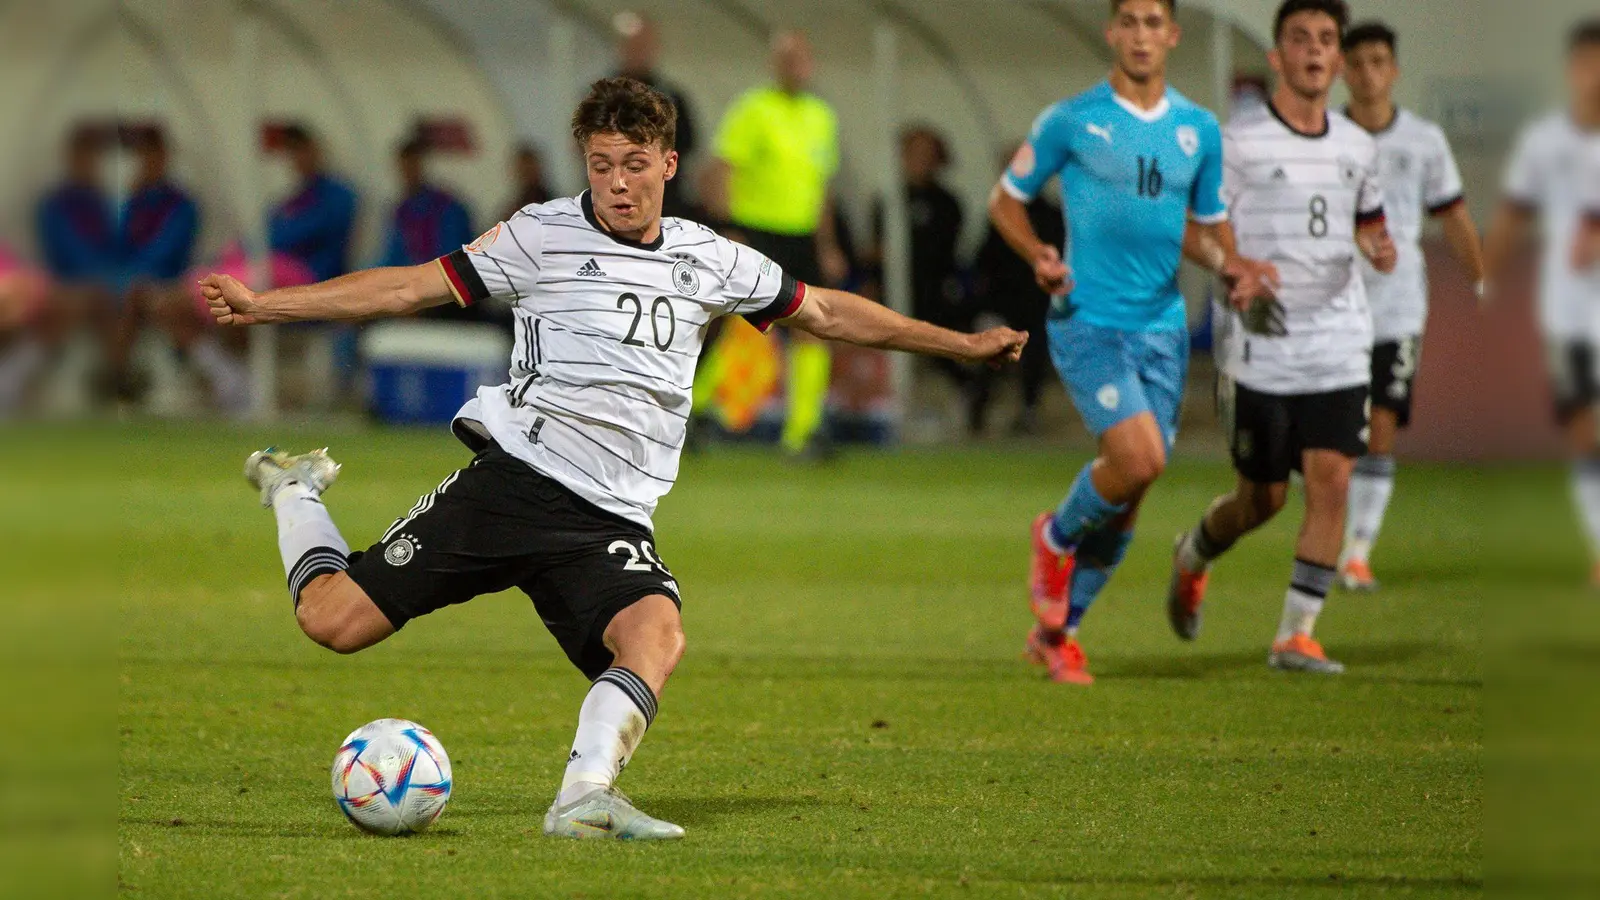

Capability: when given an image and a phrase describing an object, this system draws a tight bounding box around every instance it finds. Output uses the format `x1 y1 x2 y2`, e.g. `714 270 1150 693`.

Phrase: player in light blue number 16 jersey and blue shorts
989 0 1275 684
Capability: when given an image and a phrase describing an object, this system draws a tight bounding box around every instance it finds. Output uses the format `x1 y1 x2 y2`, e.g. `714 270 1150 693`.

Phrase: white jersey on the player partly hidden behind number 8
1360 109 1462 343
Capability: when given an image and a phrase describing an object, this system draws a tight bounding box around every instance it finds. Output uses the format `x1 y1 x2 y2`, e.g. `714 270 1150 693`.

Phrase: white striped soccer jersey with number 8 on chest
1222 106 1384 396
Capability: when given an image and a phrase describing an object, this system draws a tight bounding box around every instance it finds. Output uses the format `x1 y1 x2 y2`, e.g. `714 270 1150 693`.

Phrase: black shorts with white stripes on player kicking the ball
350 444 682 679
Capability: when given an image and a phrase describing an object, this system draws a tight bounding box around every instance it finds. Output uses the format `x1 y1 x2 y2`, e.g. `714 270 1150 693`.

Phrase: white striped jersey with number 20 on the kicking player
440 192 806 528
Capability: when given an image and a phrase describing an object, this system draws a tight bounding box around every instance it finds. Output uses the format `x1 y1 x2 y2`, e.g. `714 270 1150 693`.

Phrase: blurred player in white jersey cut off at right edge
1485 18 1600 588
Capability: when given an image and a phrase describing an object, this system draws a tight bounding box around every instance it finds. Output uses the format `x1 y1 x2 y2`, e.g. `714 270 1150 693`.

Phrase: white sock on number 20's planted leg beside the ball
555 666 656 807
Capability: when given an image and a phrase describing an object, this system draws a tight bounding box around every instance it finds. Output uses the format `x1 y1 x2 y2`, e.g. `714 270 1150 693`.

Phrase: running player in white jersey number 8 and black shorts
1166 0 1397 674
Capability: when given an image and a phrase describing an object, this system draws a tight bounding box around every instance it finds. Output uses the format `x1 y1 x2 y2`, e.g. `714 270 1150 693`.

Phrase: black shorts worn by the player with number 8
1219 380 1371 484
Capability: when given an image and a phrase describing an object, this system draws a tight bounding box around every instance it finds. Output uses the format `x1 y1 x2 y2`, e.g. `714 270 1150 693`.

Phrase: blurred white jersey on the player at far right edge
1506 112 1600 341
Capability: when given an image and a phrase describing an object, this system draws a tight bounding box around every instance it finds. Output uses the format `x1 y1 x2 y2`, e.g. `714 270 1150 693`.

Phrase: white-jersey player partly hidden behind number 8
1339 22 1483 591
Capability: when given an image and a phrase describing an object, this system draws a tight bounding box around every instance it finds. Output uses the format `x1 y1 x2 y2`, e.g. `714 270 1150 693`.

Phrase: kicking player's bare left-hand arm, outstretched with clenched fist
200 263 454 325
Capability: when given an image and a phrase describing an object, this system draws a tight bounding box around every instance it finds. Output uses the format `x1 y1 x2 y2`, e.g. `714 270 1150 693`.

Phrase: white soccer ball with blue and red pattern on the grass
333 719 450 834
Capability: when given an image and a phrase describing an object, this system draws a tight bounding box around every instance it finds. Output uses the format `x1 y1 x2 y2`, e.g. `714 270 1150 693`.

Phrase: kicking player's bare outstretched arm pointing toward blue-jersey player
782 285 1027 365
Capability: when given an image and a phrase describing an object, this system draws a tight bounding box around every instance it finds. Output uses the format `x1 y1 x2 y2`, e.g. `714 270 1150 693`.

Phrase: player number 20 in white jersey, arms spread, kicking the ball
202 78 1027 839
